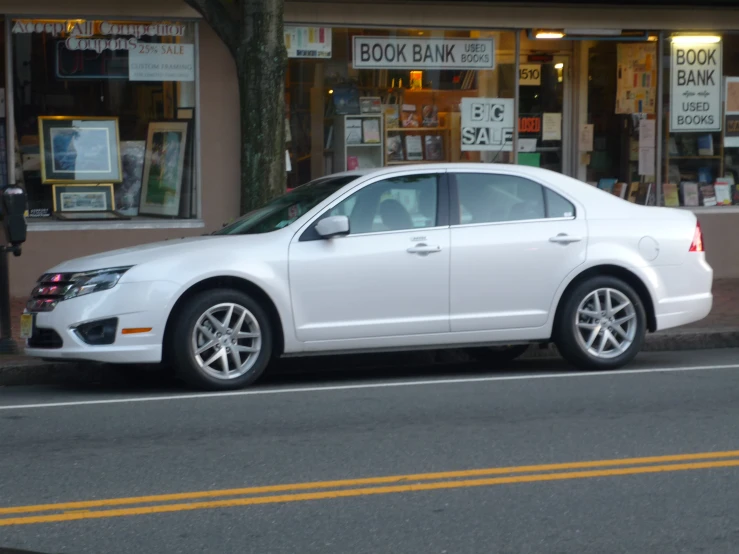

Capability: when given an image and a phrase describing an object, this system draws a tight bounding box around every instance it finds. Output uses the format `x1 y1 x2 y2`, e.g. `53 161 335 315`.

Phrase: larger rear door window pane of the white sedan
453 173 546 225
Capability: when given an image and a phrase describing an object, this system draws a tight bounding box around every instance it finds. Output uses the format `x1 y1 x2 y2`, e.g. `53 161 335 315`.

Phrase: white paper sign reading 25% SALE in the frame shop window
128 42 195 81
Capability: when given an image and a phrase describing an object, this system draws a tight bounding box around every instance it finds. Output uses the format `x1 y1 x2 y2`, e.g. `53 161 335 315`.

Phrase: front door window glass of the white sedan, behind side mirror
327 174 439 235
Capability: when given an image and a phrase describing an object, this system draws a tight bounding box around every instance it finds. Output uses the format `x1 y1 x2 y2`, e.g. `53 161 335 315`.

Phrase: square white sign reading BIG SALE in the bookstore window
460 98 514 152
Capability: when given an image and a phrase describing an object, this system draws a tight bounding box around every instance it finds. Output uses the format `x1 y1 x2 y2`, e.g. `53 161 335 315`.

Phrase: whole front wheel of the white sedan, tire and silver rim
170 289 272 390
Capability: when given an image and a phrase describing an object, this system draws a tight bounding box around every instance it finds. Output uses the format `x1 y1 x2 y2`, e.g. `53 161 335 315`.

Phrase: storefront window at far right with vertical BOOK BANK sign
662 32 739 210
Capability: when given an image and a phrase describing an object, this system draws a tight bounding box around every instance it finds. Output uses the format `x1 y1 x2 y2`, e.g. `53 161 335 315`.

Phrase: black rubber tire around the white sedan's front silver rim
168 289 273 391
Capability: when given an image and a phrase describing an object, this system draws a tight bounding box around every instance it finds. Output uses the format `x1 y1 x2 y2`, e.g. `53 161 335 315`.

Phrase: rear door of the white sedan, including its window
449 171 587 332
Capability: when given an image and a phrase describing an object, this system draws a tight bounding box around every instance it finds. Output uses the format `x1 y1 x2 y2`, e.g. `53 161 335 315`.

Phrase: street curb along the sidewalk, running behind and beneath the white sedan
0 327 739 387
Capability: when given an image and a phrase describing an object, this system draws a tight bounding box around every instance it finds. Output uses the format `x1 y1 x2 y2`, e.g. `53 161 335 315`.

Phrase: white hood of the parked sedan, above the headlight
49 235 236 273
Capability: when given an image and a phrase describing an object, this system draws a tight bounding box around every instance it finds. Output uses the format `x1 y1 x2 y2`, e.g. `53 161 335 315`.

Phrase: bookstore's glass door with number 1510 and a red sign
501 54 572 175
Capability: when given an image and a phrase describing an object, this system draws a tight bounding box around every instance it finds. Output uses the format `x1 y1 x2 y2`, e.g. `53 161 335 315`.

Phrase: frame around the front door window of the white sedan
296 169 451 237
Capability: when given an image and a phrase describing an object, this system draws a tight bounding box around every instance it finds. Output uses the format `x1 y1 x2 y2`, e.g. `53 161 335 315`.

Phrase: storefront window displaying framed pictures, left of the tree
9 19 197 221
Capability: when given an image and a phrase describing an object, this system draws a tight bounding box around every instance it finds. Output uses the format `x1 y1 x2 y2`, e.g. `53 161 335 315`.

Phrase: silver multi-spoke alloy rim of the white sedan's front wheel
191 303 262 380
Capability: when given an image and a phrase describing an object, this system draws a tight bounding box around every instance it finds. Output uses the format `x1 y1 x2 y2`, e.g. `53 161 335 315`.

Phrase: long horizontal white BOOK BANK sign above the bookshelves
353 35 495 70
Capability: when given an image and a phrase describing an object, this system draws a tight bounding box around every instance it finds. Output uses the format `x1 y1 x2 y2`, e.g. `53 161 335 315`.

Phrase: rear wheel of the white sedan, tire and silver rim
554 276 647 370
